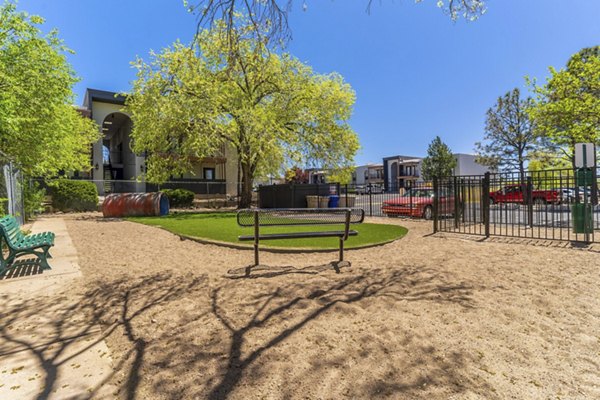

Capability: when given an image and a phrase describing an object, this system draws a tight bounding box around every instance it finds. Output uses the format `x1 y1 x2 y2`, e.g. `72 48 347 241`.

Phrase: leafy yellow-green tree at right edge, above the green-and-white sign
530 47 600 165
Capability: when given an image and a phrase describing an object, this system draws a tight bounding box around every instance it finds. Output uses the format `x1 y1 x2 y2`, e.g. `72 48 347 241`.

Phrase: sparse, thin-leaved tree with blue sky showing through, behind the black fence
475 88 541 179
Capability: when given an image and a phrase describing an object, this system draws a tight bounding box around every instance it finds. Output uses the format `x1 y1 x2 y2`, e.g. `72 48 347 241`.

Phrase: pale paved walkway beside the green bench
0 218 114 400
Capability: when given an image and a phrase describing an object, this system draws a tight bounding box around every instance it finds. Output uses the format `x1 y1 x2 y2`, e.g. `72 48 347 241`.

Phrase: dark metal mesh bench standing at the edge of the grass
237 208 365 266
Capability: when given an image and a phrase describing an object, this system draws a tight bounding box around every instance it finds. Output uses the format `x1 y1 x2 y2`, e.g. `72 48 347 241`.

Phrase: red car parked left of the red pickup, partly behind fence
381 188 455 219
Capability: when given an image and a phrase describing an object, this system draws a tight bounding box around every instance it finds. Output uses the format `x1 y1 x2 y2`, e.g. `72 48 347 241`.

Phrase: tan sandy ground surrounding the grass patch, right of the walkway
48 215 600 399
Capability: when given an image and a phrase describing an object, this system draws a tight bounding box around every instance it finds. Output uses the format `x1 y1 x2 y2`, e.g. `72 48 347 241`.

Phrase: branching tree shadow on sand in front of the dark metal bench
202 268 488 399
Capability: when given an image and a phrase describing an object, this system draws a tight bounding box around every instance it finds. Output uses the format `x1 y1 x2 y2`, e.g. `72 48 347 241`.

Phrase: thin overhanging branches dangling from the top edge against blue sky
184 0 485 45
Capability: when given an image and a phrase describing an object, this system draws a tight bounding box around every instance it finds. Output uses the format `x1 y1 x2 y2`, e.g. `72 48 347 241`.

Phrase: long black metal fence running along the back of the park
27 168 600 243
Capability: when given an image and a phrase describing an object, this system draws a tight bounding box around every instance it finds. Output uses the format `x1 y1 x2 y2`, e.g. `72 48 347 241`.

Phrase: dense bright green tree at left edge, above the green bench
0 3 99 176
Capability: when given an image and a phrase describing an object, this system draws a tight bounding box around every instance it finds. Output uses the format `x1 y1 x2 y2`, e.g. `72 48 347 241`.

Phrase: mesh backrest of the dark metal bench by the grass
237 208 365 227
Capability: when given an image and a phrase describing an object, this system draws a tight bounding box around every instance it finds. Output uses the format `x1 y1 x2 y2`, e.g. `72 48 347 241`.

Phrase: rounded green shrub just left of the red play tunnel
48 180 98 211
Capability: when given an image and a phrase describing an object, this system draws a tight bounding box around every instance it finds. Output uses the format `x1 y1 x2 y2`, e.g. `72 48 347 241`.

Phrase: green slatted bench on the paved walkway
0 215 54 277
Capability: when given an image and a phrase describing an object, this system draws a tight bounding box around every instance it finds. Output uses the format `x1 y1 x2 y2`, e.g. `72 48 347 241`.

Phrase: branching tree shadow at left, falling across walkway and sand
0 273 206 399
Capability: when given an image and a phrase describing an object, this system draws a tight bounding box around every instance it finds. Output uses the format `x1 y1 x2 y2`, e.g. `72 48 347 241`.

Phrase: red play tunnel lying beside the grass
102 192 169 218
